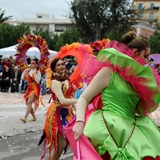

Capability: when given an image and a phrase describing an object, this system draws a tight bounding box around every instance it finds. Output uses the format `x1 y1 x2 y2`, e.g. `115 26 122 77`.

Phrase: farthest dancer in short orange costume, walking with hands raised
20 59 41 123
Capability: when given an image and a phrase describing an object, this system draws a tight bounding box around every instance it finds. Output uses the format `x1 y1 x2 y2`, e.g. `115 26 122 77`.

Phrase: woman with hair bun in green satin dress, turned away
73 31 160 160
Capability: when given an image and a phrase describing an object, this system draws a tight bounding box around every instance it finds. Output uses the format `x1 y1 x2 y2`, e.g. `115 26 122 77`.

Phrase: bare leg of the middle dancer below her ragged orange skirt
52 133 66 160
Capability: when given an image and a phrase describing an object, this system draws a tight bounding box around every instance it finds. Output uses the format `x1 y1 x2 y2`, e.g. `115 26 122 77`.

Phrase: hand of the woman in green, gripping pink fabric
72 121 84 141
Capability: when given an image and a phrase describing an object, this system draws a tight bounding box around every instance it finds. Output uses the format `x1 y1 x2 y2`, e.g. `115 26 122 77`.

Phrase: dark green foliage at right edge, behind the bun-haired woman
148 31 160 54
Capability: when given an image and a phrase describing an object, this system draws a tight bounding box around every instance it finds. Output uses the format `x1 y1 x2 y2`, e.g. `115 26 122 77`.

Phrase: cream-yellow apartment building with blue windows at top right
132 0 160 25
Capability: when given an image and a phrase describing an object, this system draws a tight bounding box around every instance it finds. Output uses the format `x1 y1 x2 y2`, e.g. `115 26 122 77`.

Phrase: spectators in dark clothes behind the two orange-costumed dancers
0 56 77 95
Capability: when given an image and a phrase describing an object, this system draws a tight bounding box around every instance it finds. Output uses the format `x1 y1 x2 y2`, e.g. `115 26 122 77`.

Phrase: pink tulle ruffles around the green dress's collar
82 41 160 115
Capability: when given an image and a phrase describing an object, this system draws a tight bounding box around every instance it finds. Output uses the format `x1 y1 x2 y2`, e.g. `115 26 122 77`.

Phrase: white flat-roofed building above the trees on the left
23 13 72 35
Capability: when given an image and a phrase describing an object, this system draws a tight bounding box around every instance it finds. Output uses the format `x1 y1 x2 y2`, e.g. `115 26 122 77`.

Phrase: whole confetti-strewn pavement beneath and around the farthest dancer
0 92 73 160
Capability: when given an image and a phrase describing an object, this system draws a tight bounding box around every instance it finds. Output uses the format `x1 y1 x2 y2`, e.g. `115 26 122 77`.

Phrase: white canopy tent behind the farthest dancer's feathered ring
0 45 57 59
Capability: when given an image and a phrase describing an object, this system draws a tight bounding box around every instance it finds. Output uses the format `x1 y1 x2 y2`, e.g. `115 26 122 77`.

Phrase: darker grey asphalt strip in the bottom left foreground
0 131 73 160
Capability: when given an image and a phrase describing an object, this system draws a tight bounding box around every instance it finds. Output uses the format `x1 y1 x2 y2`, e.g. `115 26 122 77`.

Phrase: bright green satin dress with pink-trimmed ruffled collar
84 48 160 160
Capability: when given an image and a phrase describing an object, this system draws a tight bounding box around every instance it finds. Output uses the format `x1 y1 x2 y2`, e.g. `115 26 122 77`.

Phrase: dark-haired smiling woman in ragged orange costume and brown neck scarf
38 58 77 160
